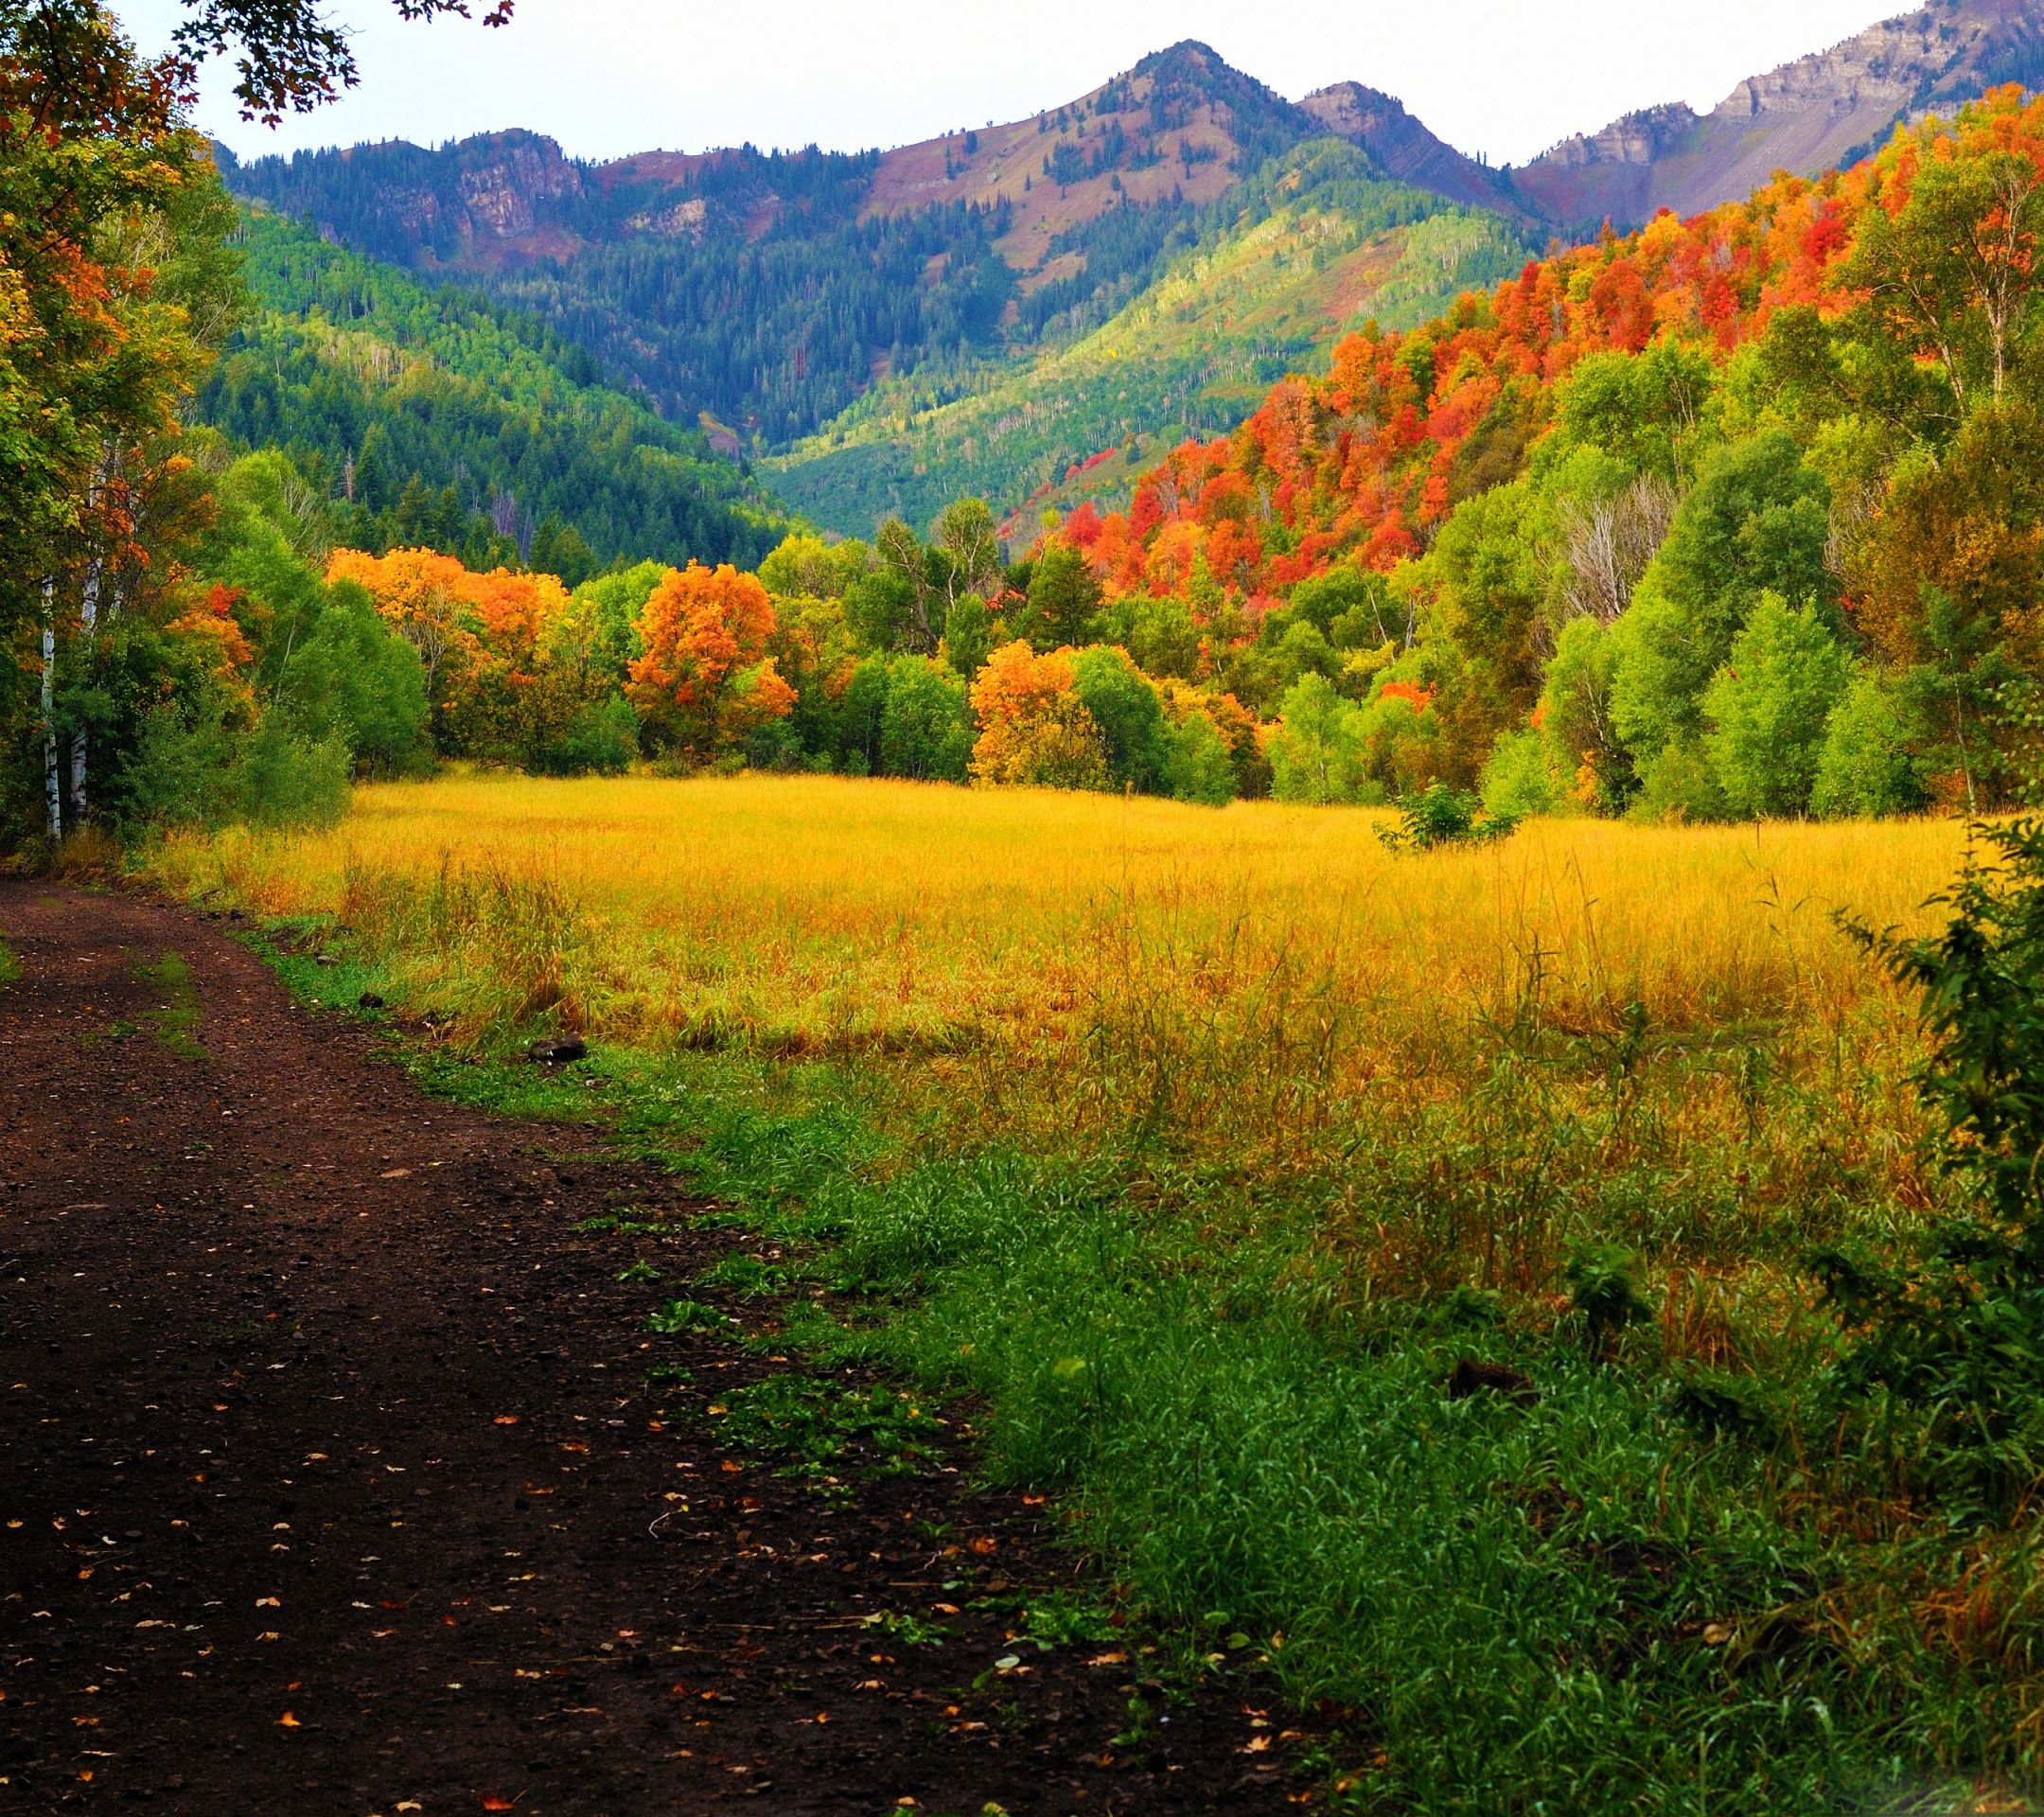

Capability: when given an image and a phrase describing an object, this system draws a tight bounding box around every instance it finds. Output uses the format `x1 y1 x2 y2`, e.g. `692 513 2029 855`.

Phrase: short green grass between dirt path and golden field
238 915 2044 1817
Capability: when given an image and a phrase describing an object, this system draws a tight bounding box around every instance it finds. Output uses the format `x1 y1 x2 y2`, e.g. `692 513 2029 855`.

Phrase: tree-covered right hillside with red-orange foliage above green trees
1017 90 2044 820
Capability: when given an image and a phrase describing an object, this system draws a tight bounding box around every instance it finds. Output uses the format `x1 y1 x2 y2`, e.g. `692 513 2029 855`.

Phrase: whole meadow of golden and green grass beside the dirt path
153 777 2044 1813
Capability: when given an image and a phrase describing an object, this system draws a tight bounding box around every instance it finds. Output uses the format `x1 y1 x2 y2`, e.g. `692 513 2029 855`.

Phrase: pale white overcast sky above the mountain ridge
113 0 1899 164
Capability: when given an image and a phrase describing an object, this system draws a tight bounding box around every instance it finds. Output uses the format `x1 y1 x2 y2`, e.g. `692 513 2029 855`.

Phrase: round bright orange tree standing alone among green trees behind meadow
626 562 795 756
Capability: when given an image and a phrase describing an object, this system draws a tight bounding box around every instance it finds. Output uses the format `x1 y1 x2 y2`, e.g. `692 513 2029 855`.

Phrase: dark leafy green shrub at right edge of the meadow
1811 820 2044 1517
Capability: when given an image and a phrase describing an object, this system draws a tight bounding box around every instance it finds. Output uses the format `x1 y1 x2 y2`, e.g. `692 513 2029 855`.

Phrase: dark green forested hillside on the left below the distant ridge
196 210 787 566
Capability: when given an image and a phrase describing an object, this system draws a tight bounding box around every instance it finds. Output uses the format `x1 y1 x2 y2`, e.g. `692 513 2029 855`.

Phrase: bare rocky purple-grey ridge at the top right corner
1510 0 2044 233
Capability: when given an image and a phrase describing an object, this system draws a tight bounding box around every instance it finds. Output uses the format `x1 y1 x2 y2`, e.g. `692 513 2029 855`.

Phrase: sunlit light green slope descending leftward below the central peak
766 141 1527 536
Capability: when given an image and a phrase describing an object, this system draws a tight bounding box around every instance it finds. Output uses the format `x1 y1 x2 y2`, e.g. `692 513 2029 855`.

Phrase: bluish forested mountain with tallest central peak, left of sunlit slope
211 43 1320 446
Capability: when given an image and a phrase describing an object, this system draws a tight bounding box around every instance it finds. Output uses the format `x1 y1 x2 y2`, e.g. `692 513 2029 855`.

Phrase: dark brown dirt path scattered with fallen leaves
0 883 1298 1817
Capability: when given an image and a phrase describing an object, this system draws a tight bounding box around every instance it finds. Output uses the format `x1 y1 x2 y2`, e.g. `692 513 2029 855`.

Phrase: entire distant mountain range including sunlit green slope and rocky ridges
211 0 2044 534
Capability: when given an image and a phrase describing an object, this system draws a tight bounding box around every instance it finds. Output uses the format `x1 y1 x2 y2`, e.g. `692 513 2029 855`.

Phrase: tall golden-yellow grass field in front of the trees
157 775 1965 1201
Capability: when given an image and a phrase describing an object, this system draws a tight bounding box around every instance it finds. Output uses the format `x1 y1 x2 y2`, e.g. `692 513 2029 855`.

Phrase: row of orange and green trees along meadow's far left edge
286 501 1267 803
